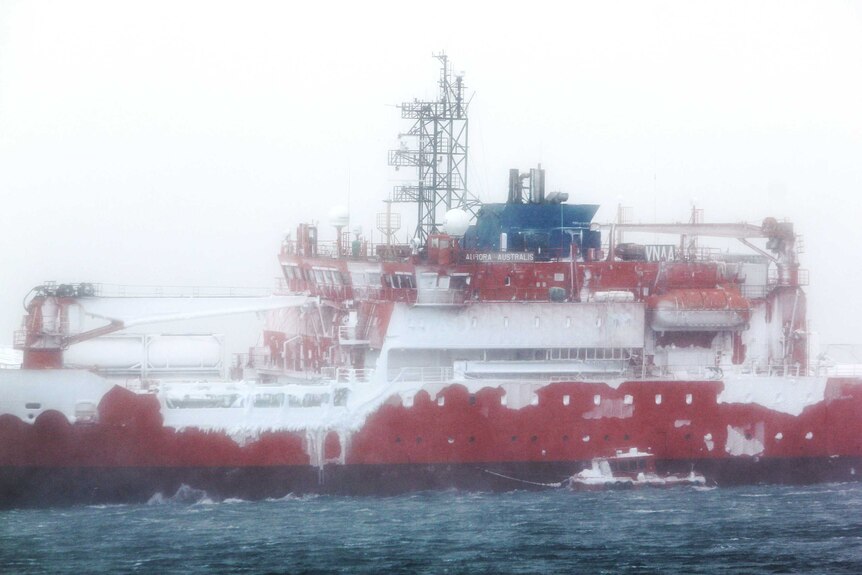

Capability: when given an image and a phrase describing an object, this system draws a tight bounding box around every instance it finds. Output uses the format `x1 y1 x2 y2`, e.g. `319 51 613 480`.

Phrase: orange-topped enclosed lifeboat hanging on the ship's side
646 288 751 332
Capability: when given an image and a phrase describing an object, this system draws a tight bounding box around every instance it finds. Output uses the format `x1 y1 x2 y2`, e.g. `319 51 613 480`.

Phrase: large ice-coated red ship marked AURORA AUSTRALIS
0 55 862 507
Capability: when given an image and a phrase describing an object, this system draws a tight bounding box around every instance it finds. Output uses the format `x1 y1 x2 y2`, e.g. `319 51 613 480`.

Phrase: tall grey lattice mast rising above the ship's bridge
389 54 480 243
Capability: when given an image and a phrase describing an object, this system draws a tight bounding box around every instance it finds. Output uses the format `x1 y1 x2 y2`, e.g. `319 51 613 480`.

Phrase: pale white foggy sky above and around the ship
0 0 862 344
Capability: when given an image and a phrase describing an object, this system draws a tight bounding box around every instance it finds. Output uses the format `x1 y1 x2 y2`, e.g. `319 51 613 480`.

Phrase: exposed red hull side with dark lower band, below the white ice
0 379 862 507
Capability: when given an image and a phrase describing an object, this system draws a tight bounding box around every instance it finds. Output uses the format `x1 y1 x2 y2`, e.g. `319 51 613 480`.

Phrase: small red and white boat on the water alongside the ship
564 447 706 491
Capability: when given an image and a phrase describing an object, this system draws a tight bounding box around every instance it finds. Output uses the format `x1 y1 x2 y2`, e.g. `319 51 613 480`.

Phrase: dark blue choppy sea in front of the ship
0 484 862 574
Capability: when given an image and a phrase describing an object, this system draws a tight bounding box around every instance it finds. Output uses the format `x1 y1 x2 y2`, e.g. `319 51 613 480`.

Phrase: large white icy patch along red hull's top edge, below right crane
718 376 826 415
